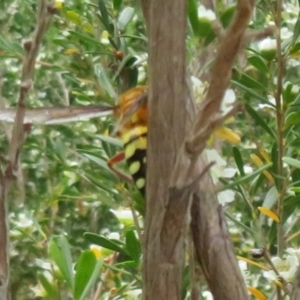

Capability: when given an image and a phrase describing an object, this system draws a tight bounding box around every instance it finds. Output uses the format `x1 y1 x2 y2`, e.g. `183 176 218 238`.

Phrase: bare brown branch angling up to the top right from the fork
186 0 254 155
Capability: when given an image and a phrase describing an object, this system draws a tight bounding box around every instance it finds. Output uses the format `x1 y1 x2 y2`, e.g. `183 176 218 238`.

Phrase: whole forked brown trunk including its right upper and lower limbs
142 0 254 300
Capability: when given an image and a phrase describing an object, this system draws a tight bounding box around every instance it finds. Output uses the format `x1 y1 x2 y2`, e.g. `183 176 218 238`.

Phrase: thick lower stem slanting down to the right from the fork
191 165 249 300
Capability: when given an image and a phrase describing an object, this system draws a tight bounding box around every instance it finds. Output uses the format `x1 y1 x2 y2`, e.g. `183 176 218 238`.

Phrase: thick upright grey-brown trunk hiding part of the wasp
143 0 188 300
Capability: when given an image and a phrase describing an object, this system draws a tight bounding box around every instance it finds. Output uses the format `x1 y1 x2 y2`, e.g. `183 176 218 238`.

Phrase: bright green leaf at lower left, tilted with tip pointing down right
49 236 74 289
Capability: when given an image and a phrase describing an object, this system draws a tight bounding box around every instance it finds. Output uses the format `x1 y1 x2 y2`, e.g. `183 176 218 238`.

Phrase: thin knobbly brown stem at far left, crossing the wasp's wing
0 0 55 300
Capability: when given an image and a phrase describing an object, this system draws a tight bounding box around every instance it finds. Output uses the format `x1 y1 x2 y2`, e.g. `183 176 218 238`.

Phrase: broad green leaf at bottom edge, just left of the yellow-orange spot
74 250 102 300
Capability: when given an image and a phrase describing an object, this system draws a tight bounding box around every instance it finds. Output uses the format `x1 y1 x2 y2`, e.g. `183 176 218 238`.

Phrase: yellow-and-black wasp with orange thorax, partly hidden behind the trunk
0 86 148 195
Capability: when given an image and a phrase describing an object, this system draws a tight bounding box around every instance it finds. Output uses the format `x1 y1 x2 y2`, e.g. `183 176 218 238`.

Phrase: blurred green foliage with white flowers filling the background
0 0 300 299
